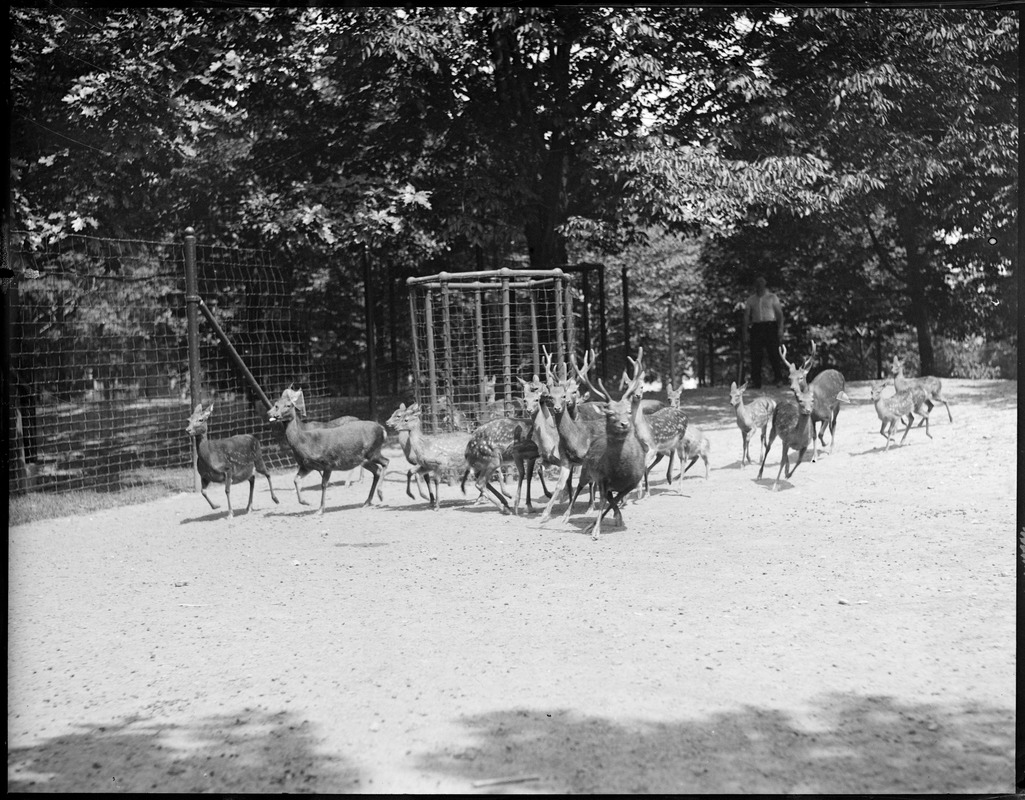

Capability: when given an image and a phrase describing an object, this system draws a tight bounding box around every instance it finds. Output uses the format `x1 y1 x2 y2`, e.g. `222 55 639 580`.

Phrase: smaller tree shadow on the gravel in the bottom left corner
7 710 361 794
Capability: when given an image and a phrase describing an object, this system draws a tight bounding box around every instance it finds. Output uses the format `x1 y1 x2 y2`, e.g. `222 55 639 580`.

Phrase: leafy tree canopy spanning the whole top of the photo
8 6 1018 377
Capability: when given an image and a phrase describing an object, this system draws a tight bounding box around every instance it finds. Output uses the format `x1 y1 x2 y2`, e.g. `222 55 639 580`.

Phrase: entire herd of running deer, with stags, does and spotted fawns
186 345 953 539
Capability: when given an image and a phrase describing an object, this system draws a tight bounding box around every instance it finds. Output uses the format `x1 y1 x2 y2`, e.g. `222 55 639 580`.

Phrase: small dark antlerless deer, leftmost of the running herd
186 403 278 519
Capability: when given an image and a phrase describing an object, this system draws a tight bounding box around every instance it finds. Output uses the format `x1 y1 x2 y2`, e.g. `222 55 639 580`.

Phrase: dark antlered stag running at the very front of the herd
570 348 647 542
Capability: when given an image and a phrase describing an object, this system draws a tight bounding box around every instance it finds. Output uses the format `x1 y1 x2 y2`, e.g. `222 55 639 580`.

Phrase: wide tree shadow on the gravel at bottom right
420 694 1014 794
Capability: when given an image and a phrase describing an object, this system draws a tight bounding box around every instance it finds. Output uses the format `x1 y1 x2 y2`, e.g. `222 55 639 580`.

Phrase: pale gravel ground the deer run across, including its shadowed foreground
7 381 1017 793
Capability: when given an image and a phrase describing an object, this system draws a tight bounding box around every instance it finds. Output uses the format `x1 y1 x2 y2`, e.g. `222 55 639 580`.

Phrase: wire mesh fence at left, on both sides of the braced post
7 233 328 491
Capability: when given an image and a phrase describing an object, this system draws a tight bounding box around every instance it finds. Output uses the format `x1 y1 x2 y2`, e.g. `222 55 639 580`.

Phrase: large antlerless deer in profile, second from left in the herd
267 387 388 514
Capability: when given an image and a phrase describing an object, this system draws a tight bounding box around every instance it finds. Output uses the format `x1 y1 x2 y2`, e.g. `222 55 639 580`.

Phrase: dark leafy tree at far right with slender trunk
709 8 1018 372
